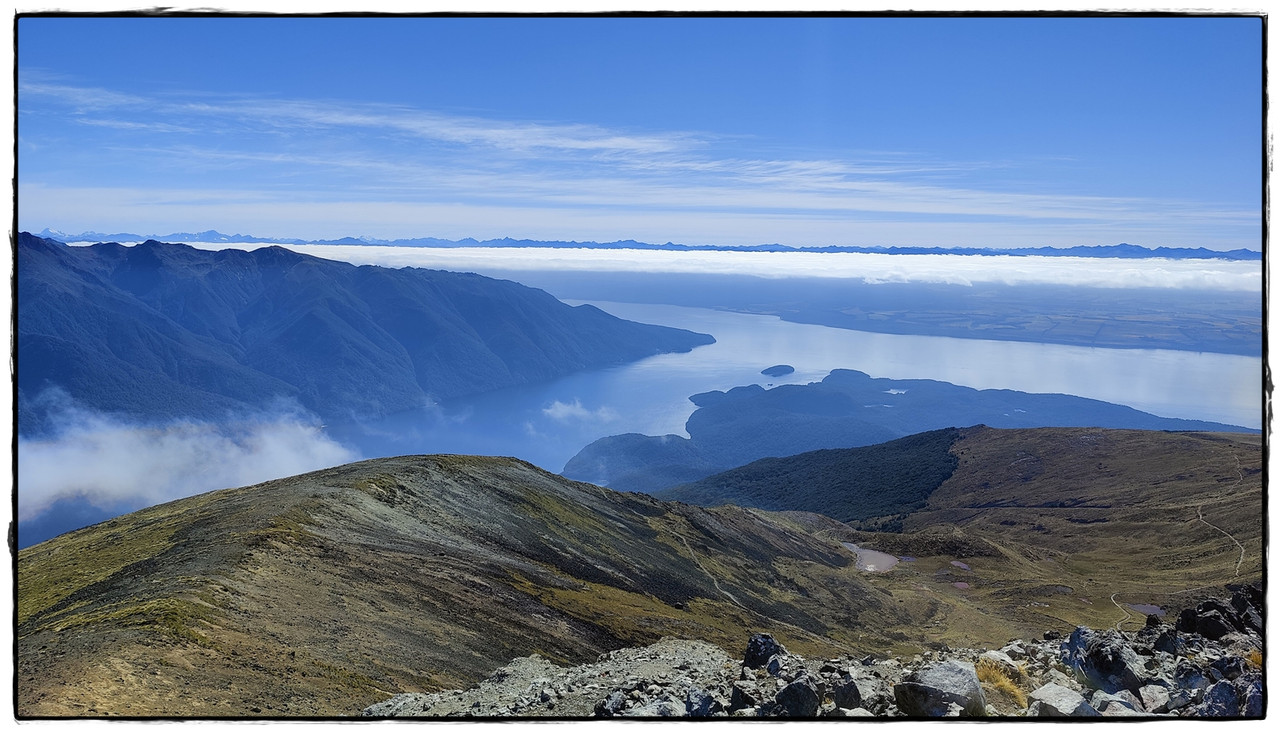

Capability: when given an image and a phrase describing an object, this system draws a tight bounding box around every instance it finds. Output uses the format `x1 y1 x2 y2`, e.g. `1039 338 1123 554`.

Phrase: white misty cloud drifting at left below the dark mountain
18 406 360 521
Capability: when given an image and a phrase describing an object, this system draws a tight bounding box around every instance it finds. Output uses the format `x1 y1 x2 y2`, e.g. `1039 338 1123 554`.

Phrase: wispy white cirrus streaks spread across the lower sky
19 74 1260 248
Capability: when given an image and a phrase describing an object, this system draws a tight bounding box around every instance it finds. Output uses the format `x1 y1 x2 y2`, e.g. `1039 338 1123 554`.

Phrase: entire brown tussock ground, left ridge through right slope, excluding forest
15 428 1263 718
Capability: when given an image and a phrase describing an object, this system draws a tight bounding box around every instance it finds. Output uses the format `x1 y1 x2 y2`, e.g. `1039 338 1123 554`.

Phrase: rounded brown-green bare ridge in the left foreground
17 456 911 716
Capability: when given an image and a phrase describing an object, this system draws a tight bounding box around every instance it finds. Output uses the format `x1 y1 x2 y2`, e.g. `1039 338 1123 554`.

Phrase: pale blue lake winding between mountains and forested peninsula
328 301 1262 472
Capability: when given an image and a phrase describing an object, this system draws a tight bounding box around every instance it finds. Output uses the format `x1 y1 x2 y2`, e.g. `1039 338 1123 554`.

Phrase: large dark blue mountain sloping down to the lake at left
17 233 714 433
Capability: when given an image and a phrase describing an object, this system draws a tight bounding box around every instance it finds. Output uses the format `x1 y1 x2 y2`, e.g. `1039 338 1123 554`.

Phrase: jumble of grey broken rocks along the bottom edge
362 586 1266 718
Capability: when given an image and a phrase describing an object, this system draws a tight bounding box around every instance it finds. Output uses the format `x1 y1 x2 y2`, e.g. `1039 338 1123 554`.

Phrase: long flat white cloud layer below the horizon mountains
172 243 1262 292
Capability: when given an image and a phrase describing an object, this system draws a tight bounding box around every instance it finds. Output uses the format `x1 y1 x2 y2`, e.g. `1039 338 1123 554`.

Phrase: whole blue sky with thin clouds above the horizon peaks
18 17 1262 250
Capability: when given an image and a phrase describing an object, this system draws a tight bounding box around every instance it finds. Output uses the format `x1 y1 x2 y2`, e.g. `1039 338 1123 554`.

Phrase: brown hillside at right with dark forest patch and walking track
668 426 1265 647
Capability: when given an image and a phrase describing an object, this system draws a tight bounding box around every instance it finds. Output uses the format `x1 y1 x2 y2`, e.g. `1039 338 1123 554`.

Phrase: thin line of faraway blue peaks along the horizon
37 228 1262 261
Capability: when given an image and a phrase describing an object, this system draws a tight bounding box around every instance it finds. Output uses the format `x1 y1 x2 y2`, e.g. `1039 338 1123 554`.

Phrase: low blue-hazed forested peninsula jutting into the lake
562 370 1256 494
